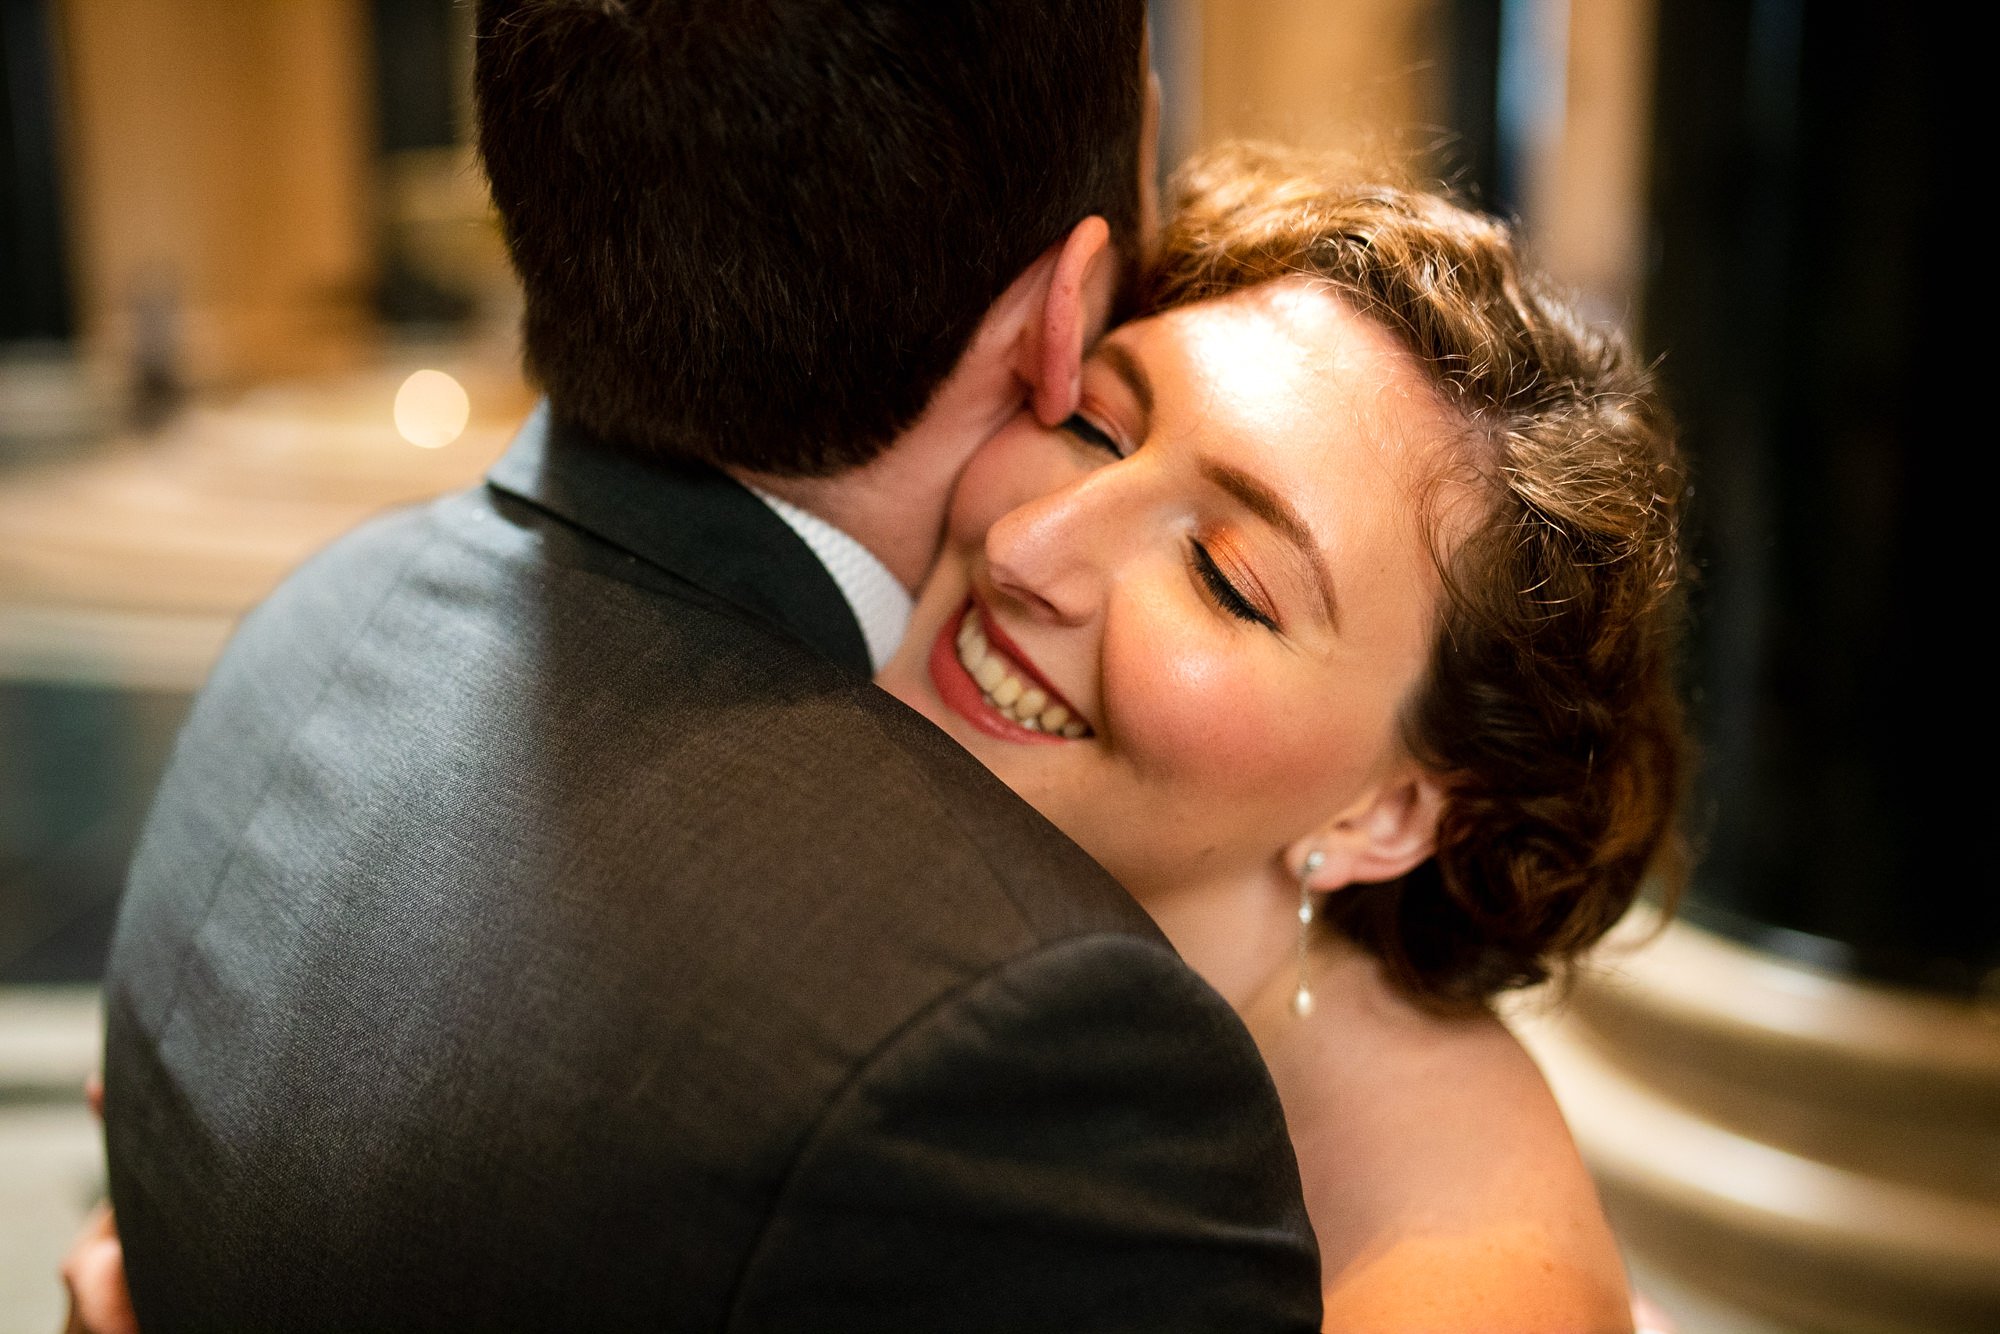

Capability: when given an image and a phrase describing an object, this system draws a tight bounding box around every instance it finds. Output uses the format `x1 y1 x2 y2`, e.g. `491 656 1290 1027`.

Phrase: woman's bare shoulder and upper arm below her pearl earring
1252 950 1630 1332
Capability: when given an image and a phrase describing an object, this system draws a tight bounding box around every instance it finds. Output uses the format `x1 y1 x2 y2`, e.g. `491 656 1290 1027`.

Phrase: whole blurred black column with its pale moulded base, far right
1502 0 2000 1334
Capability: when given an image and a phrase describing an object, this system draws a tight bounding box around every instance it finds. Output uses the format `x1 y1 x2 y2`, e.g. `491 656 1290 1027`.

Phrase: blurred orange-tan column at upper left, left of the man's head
60 0 374 384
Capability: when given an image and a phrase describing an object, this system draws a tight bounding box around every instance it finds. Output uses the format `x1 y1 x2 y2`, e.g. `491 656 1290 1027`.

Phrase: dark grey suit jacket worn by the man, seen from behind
106 418 1318 1334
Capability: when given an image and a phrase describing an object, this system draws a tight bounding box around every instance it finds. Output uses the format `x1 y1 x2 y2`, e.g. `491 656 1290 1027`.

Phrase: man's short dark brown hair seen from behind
474 0 1144 476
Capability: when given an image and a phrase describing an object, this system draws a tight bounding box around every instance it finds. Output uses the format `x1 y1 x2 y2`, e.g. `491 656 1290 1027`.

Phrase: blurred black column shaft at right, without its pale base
1648 0 2000 998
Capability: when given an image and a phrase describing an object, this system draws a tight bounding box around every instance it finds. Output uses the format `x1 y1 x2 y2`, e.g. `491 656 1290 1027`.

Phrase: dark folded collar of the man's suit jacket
486 402 868 676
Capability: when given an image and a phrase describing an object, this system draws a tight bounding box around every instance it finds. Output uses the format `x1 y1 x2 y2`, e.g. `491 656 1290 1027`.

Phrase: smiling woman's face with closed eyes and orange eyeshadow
882 280 1460 900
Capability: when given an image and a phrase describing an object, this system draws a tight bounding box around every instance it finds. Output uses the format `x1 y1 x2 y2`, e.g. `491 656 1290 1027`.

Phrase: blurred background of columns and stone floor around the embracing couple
0 0 1976 1334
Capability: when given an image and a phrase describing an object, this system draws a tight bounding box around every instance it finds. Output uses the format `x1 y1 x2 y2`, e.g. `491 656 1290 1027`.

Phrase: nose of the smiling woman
986 468 1118 624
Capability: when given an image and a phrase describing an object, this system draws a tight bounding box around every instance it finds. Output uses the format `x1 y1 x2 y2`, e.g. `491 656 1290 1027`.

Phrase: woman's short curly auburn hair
1142 146 1688 1012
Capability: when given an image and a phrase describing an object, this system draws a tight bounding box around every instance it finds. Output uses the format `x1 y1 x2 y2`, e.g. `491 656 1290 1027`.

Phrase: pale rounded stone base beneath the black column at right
1510 912 2000 1334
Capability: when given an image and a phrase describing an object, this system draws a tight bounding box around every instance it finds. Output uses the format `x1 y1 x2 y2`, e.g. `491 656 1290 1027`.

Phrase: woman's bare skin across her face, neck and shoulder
880 282 1630 1334
